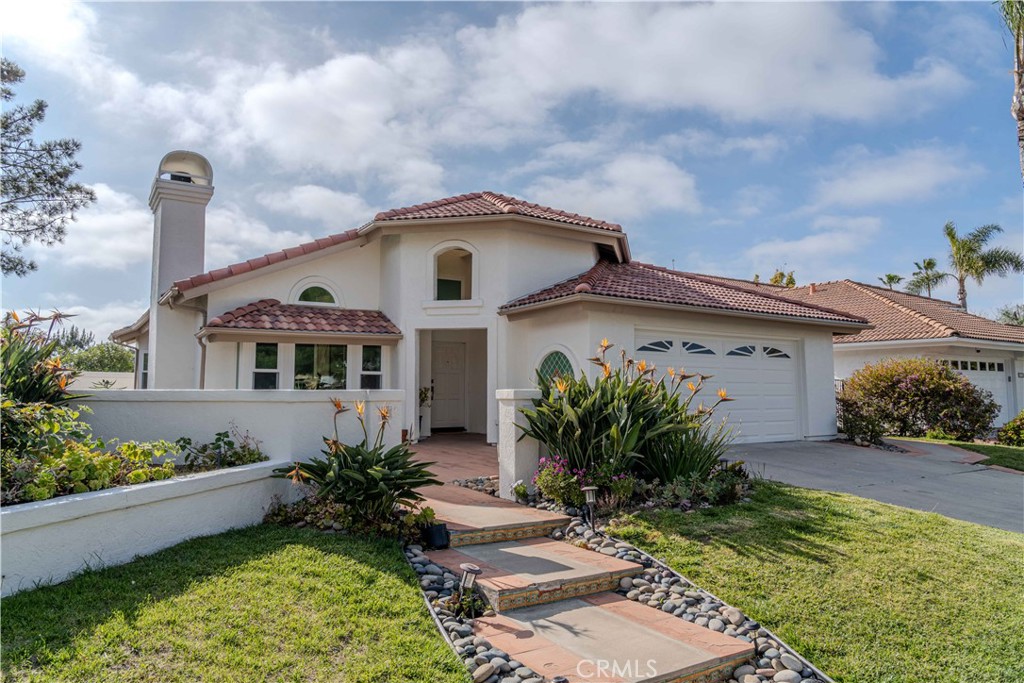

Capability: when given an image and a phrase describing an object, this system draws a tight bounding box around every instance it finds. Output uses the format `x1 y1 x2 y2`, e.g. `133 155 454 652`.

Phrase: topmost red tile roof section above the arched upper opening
374 191 623 232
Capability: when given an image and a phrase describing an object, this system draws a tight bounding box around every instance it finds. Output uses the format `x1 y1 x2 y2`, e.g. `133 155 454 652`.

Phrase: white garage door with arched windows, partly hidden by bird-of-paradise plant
635 331 804 442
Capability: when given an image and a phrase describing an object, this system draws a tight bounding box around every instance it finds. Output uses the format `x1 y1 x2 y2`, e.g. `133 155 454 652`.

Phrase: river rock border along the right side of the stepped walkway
551 516 835 683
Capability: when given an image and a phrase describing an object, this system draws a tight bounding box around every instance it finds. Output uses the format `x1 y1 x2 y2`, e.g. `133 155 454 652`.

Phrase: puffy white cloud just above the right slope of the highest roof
526 154 701 221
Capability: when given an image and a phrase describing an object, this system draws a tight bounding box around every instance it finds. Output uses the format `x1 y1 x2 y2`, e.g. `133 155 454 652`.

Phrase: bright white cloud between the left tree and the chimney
27 182 153 270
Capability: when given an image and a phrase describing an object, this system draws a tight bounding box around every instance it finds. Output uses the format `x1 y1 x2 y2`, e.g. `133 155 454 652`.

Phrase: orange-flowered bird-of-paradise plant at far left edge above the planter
0 311 77 403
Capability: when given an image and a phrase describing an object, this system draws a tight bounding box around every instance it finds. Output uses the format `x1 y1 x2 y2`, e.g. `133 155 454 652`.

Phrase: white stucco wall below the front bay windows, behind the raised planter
76 390 408 460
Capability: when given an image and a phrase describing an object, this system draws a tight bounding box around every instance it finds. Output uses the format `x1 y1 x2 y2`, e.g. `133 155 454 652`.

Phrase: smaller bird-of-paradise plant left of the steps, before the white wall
274 398 441 526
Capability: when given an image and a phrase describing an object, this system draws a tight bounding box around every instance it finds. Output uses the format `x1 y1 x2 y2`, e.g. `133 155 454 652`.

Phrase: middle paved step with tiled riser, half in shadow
427 539 643 612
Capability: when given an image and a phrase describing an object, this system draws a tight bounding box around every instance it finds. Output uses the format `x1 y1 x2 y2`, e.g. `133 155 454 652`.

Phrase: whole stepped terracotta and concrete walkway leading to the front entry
416 434 753 683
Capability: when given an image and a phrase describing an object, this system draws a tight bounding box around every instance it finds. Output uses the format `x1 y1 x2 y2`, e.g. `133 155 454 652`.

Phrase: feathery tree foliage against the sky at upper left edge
0 59 96 276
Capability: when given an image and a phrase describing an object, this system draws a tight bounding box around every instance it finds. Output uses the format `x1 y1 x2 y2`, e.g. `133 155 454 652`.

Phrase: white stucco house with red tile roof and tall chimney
114 152 868 442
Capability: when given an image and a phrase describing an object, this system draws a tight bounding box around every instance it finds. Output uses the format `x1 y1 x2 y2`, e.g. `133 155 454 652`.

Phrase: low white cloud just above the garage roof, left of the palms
743 216 882 283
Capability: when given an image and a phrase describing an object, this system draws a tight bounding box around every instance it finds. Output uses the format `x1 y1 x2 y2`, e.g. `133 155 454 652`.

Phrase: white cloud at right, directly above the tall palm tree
805 146 982 211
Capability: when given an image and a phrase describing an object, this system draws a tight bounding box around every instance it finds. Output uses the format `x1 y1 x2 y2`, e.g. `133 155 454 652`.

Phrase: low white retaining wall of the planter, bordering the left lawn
0 460 296 595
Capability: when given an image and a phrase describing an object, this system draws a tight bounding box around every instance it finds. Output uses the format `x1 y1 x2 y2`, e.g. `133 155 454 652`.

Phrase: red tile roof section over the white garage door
501 261 866 325
